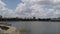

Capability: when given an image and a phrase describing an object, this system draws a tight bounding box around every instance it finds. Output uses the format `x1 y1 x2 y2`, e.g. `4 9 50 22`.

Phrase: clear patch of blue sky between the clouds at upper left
2 0 21 9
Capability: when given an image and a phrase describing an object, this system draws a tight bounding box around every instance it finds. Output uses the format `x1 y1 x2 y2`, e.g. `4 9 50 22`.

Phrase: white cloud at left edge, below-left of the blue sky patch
0 0 16 17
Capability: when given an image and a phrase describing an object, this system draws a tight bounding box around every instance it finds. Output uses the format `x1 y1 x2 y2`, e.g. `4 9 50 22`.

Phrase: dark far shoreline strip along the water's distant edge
0 18 60 22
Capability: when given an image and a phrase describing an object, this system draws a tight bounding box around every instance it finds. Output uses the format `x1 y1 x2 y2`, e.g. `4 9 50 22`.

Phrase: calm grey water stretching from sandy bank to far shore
0 21 60 34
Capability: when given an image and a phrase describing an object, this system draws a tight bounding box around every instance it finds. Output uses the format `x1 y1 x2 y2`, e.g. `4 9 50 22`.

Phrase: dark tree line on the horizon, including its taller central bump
0 17 60 21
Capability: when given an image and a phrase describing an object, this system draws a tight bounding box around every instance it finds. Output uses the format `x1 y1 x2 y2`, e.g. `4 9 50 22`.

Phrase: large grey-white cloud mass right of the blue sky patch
16 0 60 18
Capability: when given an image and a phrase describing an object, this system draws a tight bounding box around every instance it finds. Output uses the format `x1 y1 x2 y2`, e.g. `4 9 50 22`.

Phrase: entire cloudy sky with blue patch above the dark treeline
0 0 60 18
